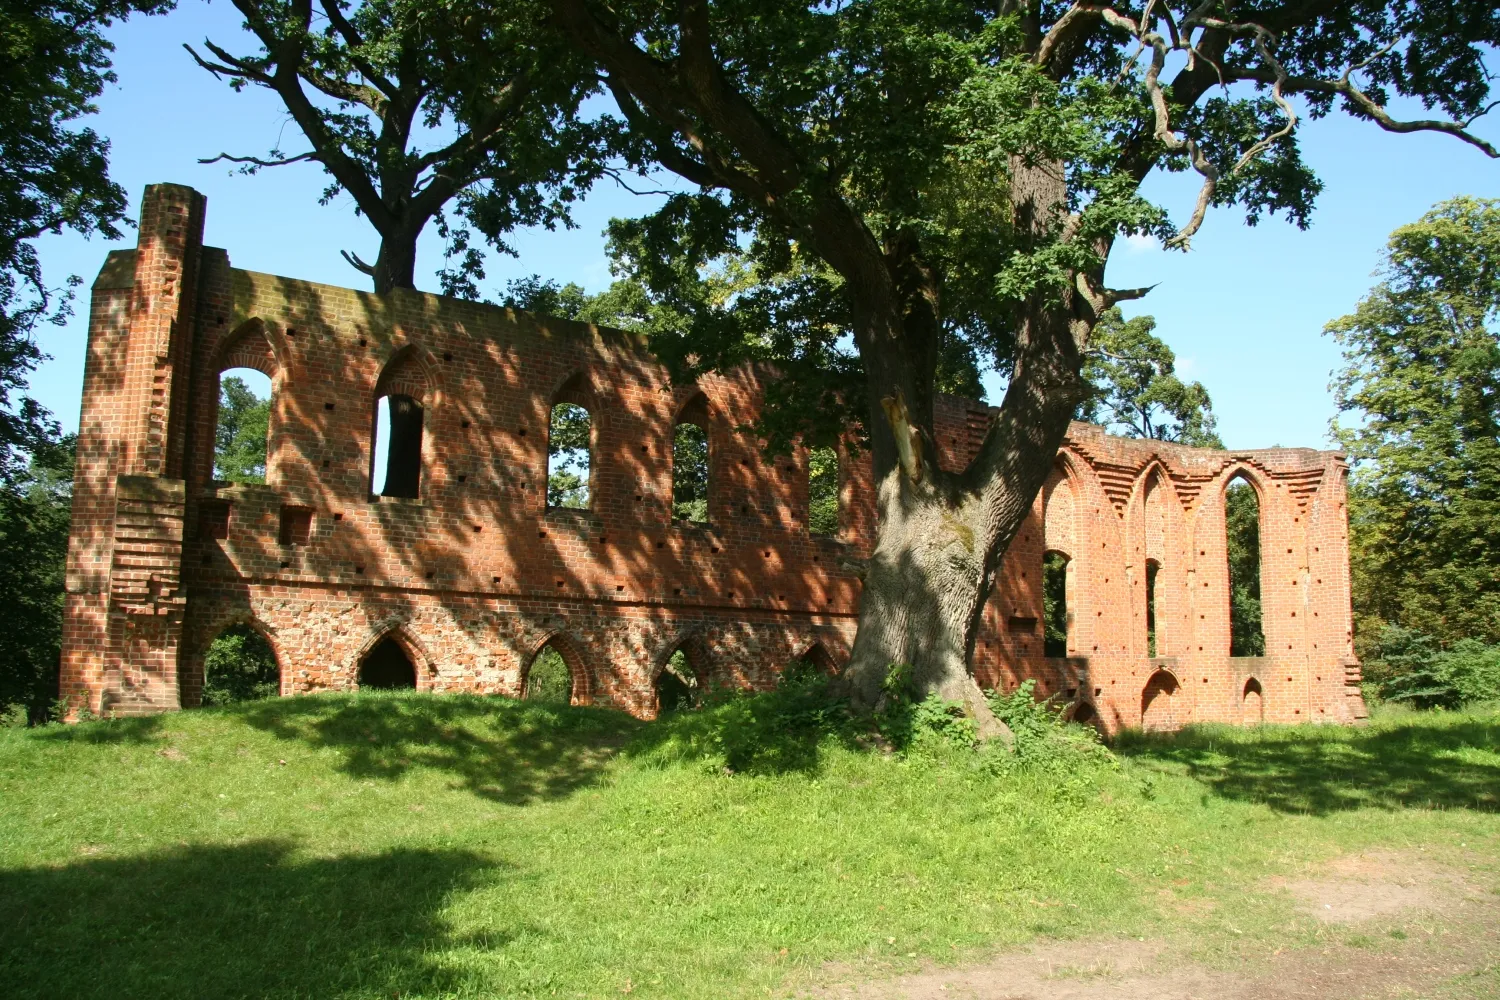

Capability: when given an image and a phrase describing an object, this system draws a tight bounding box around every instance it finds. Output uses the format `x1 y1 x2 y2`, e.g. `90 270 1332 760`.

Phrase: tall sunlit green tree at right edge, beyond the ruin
1328 198 1500 646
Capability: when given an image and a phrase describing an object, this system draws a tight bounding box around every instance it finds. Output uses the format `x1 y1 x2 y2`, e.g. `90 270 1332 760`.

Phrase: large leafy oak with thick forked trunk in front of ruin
554 0 1500 721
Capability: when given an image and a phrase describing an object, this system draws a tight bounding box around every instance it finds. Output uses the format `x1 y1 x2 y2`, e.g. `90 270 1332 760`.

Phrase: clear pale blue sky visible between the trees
32 0 1500 448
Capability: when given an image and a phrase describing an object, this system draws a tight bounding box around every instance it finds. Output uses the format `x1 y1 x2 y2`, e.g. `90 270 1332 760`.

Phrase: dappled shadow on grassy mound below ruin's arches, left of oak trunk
233 693 642 805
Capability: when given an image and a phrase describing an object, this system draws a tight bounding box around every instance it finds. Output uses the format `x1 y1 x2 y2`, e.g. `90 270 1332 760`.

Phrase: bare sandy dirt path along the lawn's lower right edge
809 855 1500 1000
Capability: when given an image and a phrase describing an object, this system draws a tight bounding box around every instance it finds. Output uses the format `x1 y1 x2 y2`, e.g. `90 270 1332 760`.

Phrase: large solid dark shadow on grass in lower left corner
0 841 494 1000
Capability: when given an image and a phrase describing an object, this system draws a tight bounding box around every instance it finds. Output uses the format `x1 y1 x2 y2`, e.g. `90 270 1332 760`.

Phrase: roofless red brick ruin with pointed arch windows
62 184 1365 732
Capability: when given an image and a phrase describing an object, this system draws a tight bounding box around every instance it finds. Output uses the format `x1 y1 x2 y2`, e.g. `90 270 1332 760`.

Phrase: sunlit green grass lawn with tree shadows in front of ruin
0 694 1500 1000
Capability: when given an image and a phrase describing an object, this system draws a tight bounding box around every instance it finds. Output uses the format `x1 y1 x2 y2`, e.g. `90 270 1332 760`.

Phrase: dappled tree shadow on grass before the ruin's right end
1115 715 1500 816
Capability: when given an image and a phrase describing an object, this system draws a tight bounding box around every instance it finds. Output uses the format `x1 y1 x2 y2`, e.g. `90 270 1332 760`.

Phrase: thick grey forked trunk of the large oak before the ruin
845 156 1097 732
